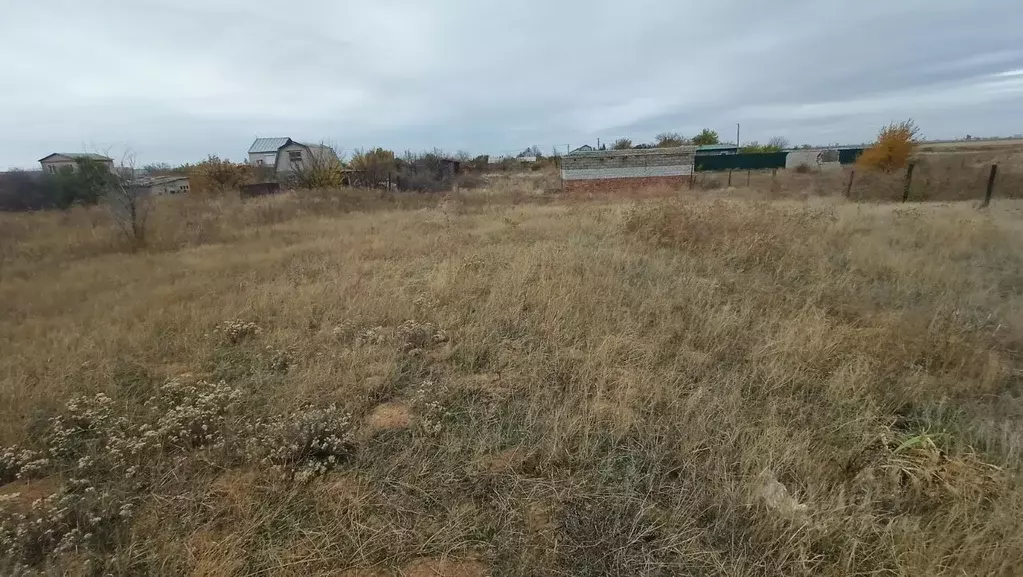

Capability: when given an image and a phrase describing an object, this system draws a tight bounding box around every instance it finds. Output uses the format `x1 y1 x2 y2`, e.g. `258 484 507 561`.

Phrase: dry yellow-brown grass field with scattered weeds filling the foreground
0 187 1023 577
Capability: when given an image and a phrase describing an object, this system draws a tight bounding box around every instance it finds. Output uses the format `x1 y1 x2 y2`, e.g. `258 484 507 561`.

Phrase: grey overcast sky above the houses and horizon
0 0 1023 168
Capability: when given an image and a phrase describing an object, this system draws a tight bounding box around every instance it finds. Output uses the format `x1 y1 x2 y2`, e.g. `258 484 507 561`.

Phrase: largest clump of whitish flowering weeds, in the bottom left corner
0 381 353 565
